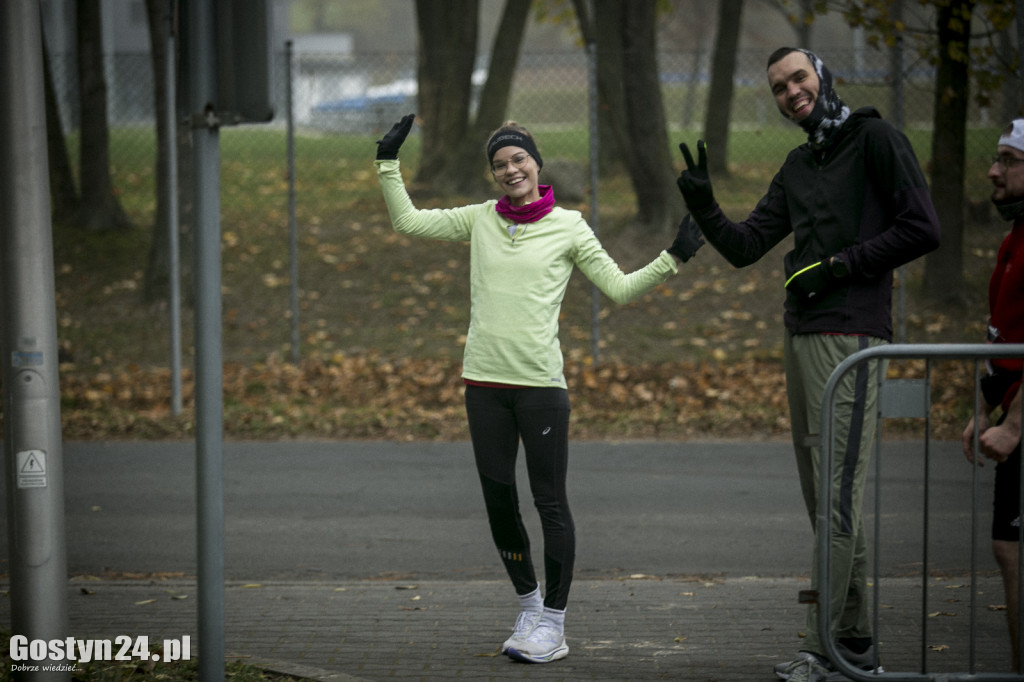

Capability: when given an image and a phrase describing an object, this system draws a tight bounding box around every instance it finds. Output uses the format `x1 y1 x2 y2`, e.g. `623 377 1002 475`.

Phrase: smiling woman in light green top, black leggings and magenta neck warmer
375 114 703 663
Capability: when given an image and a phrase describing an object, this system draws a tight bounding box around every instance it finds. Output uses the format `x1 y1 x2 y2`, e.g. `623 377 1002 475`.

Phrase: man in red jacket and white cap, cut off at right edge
964 119 1024 672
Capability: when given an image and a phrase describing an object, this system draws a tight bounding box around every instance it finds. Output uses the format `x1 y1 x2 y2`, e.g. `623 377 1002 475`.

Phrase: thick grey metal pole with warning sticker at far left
0 0 71 680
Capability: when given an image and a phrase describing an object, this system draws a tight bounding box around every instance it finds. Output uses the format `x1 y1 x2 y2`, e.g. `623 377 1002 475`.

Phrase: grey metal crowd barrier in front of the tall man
816 344 1024 682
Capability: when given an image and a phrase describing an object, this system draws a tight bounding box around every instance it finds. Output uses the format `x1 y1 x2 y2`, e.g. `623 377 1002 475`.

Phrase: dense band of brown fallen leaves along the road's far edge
51 348 973 440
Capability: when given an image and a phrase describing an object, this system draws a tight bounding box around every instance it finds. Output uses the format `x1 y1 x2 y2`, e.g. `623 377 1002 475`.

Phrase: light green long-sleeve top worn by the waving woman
375 156 677 388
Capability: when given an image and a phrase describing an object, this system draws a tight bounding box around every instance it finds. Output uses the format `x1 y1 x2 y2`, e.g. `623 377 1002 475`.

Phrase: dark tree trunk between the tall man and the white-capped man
925 0 974 300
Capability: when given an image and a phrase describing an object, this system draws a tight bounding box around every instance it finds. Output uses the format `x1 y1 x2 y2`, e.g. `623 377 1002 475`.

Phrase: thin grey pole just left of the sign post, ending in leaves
166 0 181 417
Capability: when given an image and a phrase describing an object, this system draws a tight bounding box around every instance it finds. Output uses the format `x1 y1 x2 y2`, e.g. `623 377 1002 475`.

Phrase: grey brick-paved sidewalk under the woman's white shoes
28 576 1008 682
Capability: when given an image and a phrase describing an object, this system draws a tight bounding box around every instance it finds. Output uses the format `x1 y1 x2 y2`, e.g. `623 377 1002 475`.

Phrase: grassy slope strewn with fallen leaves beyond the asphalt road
19 168 1005 440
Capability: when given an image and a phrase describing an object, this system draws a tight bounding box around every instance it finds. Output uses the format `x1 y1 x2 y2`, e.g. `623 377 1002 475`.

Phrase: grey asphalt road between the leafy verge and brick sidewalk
0 441 994 581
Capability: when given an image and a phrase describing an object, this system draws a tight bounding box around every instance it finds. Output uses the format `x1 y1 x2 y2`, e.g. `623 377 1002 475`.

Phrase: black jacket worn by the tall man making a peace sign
693 106 940 341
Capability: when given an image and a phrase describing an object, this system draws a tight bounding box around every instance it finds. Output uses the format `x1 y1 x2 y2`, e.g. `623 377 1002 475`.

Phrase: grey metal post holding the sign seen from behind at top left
187 0 224 680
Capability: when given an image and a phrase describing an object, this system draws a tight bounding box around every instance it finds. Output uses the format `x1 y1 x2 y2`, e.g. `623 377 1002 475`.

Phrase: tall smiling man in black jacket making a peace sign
678 47 939 682
